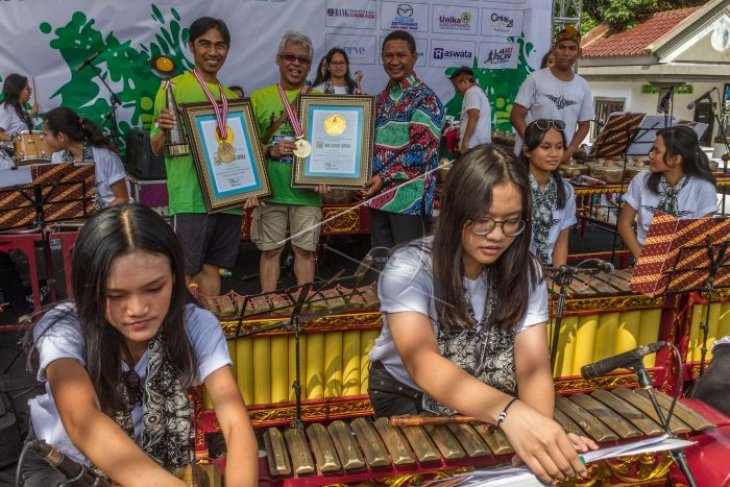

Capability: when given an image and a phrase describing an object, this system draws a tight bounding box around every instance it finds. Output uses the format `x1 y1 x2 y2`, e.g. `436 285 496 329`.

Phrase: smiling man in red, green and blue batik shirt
363 30 444 247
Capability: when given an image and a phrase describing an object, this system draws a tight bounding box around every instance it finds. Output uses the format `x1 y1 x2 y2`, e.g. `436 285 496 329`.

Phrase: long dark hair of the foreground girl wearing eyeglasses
433 144 542 330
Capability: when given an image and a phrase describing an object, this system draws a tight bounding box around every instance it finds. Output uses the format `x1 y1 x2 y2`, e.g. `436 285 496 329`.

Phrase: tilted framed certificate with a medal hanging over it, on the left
180 100 271 212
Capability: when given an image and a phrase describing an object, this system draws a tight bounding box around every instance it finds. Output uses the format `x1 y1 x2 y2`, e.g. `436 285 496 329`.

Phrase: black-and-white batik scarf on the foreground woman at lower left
114 336 195 471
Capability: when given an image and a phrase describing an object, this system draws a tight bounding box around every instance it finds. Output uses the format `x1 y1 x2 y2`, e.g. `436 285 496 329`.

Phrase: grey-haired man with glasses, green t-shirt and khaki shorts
251 31 329 292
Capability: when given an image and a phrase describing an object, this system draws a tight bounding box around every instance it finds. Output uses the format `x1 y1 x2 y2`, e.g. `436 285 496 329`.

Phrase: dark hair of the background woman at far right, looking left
646 125 715 194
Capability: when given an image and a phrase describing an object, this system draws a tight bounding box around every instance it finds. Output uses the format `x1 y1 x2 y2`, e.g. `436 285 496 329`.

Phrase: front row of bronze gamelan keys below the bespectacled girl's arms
262 388 715 485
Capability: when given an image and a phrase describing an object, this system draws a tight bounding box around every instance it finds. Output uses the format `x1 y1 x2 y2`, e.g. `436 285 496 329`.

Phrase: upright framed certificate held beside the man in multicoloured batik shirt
292 94 375 189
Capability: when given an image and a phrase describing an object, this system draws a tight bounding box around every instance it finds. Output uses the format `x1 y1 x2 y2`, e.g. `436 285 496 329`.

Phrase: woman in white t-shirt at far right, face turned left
618 125 717 258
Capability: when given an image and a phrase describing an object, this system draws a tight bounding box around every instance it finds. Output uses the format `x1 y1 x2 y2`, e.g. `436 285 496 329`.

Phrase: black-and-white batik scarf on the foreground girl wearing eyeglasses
422 270 517 415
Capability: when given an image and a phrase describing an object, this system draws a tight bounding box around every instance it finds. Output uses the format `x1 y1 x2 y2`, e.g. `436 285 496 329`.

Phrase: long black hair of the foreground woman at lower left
26 203 197 414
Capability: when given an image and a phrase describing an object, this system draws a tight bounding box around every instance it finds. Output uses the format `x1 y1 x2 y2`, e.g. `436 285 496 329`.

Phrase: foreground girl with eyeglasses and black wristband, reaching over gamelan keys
368 145 596 482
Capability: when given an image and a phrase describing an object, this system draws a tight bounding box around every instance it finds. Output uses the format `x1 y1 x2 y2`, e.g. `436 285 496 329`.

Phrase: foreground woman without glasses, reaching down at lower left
22 204 258 487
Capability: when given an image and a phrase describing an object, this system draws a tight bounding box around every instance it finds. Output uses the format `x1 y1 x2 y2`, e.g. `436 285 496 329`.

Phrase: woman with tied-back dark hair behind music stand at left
43 107 130 210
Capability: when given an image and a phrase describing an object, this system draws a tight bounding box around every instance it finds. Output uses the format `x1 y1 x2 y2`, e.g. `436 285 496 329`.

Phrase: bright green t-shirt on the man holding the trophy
150 71 242 215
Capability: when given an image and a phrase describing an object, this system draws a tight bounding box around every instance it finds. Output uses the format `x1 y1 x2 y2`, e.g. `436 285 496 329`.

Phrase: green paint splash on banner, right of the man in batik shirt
446 32 534 131
